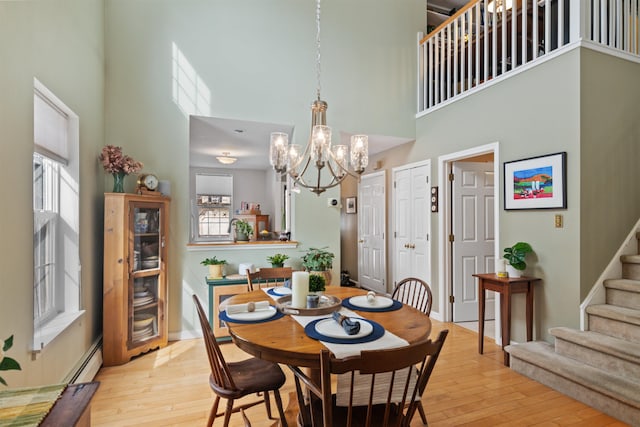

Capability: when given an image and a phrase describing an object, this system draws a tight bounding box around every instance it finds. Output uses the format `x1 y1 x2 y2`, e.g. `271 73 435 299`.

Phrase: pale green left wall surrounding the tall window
0 0 104 387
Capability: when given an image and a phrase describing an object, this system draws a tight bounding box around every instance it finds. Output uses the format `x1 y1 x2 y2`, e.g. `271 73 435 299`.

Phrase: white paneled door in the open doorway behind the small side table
452 162 495 322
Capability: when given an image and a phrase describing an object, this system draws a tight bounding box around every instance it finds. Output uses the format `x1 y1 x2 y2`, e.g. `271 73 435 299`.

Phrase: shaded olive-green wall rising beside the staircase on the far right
580 49 640 298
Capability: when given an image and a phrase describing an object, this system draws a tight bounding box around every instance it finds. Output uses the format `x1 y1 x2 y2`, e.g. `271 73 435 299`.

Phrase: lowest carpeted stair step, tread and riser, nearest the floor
506 341 640 426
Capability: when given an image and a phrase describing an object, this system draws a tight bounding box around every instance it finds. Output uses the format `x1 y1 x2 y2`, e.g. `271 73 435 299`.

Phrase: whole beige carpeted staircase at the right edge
506 232 640 426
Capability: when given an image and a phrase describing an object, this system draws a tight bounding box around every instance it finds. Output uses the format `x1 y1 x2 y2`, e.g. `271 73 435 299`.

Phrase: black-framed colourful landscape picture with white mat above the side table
504 152 567 210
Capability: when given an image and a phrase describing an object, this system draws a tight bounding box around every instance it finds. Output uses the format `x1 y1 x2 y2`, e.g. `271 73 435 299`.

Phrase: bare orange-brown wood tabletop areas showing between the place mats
226 286 431 369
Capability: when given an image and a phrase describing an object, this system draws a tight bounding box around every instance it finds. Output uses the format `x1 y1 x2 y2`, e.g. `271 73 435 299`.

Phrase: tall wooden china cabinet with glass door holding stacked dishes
102 193 169 366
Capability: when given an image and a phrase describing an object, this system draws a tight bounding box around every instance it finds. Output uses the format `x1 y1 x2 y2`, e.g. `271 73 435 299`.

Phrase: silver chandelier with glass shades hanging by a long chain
269 0 369 196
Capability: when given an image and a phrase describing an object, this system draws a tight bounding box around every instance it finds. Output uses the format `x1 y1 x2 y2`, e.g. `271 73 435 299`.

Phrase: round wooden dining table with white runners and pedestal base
220 286 431 427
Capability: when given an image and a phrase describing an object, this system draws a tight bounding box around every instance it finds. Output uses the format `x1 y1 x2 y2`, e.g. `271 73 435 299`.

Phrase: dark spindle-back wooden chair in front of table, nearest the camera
289 330 449 427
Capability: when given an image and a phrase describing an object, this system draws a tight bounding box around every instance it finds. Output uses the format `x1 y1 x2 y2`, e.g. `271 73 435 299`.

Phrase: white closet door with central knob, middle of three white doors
393 162 431 290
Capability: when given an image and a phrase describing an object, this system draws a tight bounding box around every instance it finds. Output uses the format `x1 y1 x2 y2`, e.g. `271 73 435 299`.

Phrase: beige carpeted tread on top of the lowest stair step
505 341 640 408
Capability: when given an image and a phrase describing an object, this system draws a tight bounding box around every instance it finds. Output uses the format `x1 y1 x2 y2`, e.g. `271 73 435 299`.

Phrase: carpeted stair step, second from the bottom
549 327 640 383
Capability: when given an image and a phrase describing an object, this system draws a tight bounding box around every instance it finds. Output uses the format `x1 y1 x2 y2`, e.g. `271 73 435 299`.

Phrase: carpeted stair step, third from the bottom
586 304 640 343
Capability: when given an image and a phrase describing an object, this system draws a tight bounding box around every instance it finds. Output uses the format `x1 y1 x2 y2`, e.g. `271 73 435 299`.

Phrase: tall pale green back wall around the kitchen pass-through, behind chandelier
105 0 424 337
